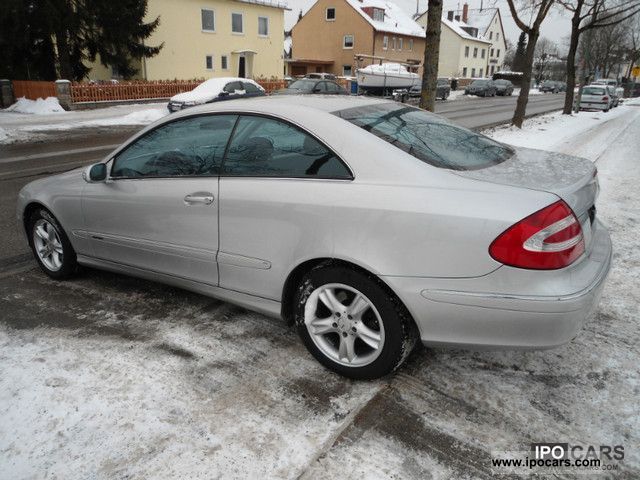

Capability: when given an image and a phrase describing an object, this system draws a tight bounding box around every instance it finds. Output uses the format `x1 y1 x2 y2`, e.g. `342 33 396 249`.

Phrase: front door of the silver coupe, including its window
82 115 237 285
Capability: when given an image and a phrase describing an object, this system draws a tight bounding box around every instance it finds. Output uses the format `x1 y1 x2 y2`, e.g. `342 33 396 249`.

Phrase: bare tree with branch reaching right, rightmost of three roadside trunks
558 0 640 115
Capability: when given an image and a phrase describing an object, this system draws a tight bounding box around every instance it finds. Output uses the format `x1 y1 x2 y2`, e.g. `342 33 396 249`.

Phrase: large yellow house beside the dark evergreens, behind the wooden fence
88 0 286 80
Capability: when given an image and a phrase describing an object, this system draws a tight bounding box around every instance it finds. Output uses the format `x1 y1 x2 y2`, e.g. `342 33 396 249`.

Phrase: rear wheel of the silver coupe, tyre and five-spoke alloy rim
294 264 418 380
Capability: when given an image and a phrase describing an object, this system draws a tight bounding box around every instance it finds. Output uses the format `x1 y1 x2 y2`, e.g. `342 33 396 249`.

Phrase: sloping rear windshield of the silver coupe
333 103 513 170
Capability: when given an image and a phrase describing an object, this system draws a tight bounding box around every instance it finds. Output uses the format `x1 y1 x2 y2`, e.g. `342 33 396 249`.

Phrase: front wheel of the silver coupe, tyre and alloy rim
28 208 78 280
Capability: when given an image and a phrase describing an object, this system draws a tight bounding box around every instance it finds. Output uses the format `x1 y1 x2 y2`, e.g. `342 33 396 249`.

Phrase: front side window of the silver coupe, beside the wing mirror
111 115 237 178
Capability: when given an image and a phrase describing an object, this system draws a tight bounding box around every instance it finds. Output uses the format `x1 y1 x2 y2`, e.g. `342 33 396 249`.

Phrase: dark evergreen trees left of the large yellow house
0 0 162 80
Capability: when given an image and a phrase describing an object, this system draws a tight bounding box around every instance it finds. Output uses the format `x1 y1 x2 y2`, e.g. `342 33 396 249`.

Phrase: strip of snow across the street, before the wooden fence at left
0 102 169 144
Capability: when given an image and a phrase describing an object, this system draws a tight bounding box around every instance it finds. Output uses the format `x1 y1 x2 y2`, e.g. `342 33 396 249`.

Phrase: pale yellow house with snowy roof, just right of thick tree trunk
416 12 491 78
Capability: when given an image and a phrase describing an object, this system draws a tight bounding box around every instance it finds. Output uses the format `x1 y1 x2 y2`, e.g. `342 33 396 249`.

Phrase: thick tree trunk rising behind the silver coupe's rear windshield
420 0 442 112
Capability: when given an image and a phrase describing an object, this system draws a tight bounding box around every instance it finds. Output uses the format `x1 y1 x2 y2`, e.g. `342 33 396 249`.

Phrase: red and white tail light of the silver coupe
489 200 584 270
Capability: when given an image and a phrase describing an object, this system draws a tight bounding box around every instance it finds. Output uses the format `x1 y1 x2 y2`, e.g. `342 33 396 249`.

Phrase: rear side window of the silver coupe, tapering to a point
223 116 351 179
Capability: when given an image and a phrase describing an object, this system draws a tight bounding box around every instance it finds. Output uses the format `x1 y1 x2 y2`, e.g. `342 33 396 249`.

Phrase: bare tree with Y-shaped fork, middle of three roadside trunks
507 0 555 128
